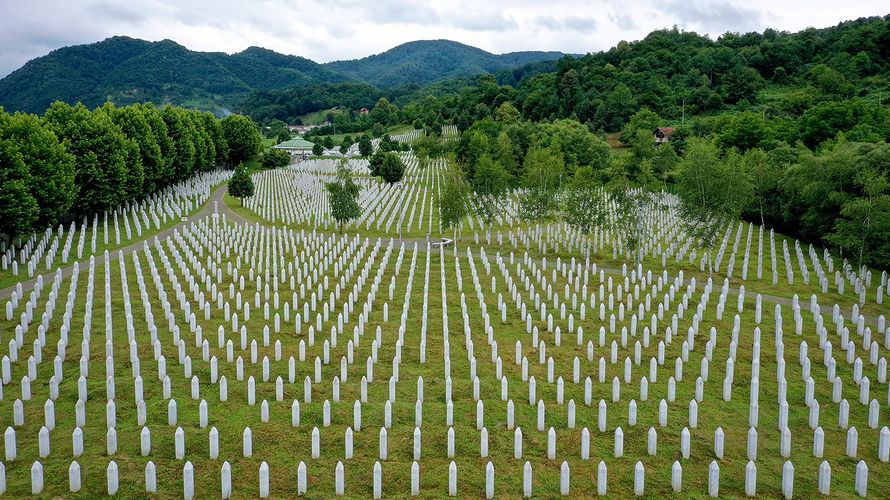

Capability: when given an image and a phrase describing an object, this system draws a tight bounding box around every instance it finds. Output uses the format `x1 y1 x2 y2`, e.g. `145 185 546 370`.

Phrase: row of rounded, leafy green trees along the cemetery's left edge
0 102 262 240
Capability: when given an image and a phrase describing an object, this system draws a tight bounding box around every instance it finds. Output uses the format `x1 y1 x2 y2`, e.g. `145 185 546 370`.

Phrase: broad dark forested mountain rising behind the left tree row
0 36 349 113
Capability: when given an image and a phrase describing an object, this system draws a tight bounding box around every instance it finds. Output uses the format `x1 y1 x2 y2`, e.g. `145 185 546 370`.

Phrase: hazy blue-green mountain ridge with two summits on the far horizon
0 36 563 114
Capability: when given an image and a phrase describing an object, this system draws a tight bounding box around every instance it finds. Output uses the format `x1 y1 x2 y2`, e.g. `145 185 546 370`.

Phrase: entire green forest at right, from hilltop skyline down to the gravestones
398 18 890 269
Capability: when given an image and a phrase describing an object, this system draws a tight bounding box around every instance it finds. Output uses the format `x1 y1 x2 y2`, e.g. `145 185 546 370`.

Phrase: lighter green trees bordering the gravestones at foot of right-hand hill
441 111 890 269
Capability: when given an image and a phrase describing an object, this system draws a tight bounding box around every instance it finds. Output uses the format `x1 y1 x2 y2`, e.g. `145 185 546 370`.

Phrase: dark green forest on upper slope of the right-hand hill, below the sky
422 18 890 131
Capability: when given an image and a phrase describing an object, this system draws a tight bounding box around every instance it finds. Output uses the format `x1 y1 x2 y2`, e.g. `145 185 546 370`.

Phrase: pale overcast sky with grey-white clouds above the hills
0 0 890 77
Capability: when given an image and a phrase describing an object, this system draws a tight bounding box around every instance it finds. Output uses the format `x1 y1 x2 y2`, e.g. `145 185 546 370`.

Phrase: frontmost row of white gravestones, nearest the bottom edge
0 460 869 500
